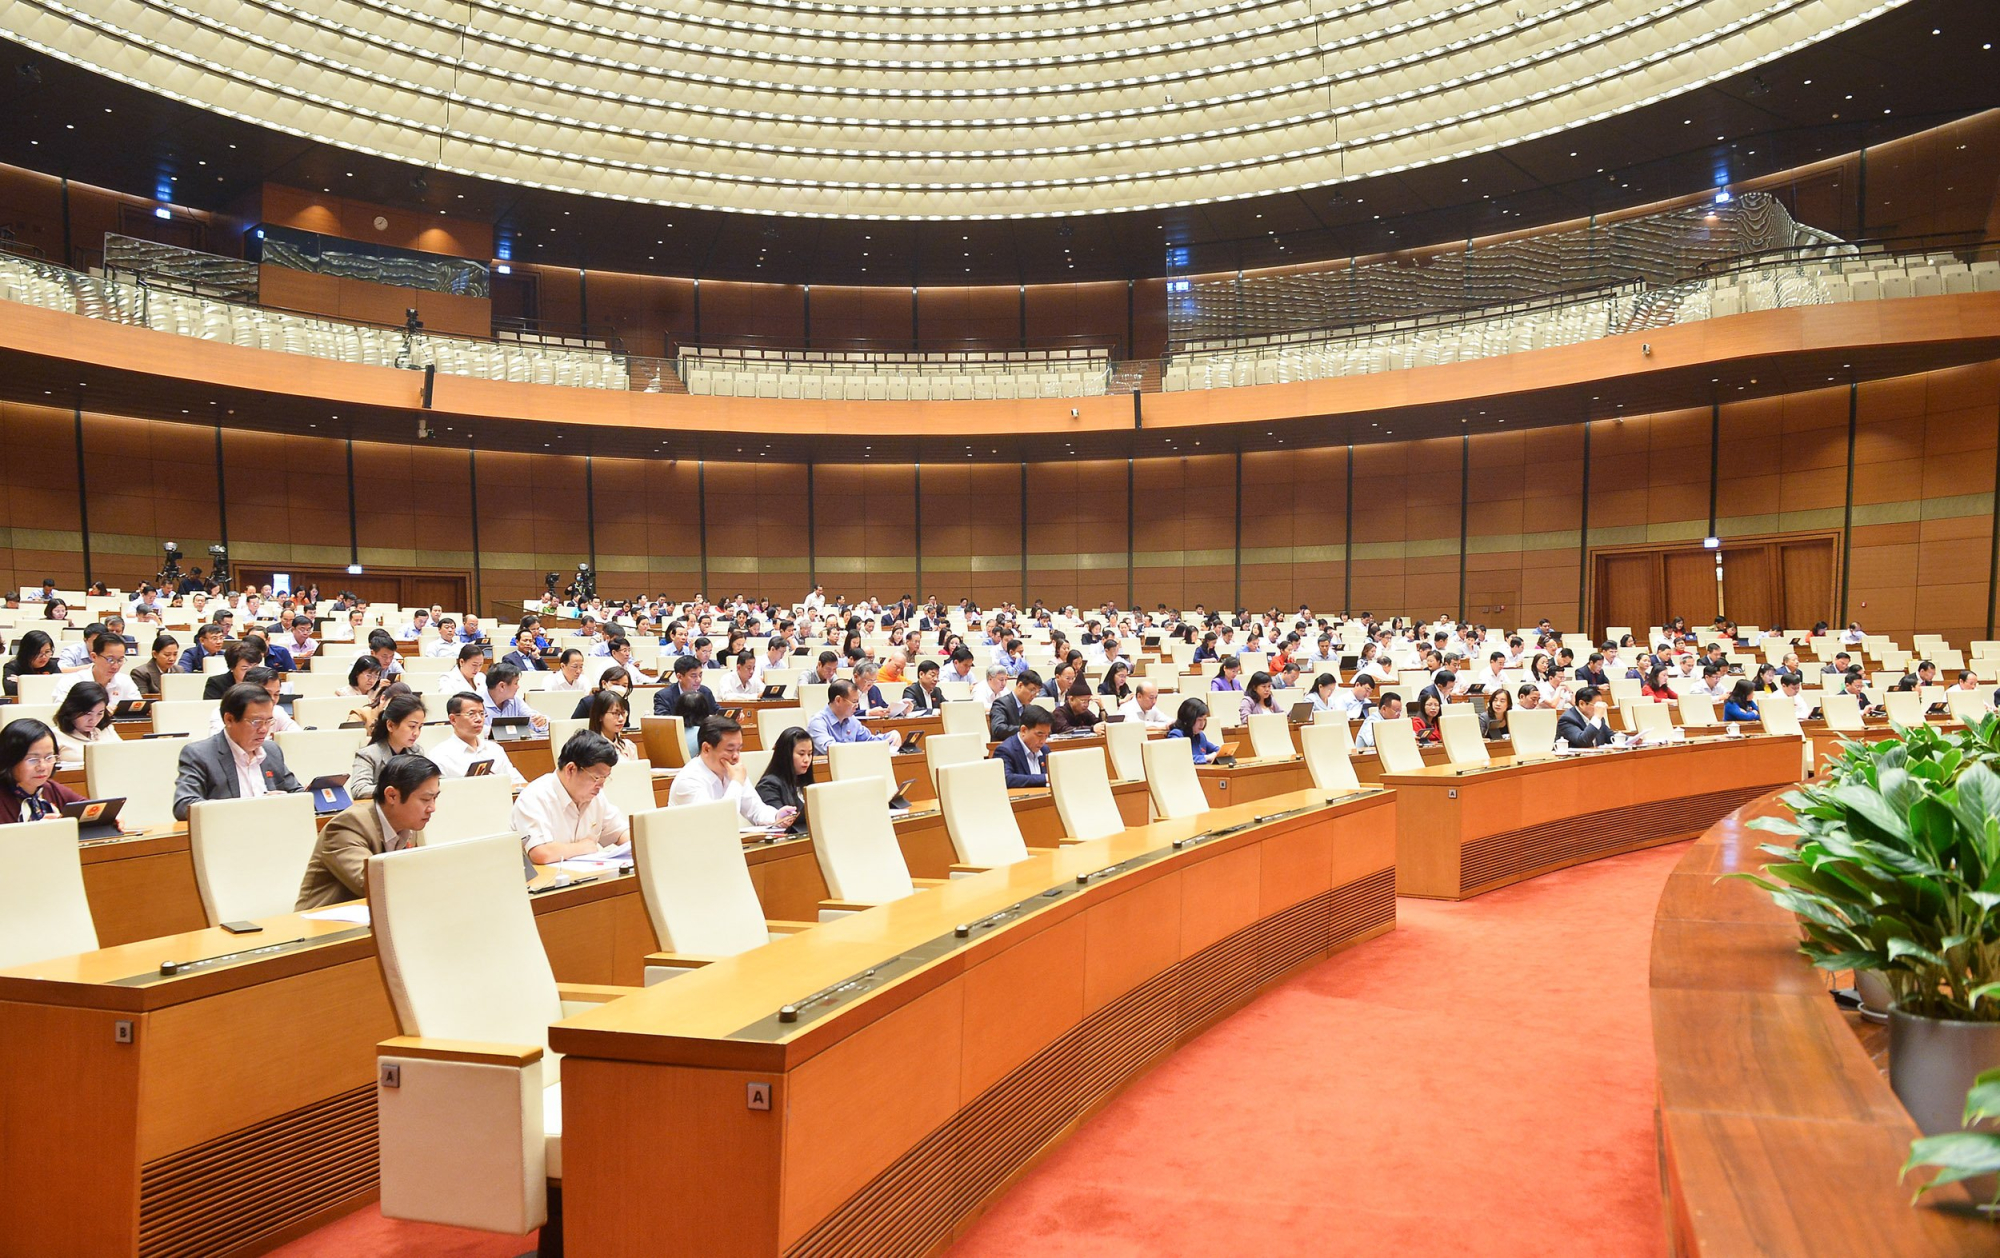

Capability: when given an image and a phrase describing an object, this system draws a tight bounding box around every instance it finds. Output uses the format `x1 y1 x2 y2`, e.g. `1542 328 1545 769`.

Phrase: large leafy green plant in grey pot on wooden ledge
1736 716 2000 1160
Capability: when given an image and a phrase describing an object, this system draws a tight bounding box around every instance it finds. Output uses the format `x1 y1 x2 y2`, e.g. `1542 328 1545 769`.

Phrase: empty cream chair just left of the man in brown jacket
188 792 320 926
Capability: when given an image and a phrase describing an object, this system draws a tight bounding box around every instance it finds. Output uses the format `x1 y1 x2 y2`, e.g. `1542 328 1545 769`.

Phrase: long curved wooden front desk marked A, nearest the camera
550 792 1396 1258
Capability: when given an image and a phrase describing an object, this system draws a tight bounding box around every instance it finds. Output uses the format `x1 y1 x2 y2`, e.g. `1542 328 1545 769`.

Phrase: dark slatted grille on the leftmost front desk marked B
138 1082 376 1258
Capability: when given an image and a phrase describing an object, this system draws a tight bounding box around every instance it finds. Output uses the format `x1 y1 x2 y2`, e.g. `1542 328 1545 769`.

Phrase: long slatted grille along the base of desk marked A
786 868 1396 1258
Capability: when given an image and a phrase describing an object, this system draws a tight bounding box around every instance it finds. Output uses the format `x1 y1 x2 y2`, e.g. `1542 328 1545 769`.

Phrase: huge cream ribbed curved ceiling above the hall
0 0 1908 220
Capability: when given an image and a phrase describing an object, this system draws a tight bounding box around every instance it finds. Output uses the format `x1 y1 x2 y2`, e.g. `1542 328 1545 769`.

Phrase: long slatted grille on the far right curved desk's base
1458 786 1770 896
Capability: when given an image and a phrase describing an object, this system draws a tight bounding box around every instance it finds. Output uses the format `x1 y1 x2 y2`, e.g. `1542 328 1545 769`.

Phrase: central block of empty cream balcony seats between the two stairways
678 346 1110 402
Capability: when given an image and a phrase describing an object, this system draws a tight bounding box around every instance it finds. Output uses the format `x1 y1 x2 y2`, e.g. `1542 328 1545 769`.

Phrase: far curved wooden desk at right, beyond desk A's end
1380 736 1800 900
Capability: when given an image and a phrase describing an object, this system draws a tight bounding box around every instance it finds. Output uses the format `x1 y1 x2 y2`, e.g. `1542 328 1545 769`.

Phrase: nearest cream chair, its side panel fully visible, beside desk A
368 836 628 1236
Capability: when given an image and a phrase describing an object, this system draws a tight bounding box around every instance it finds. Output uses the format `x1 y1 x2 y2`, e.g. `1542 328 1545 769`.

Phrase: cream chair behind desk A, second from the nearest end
632 800 806 986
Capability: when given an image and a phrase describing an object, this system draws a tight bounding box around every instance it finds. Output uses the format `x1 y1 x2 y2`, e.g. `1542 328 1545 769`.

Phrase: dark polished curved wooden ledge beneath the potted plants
1652 796 2000 1258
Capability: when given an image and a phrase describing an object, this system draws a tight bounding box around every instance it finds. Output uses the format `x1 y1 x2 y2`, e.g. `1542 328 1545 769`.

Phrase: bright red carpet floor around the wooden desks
278 846 1682 1258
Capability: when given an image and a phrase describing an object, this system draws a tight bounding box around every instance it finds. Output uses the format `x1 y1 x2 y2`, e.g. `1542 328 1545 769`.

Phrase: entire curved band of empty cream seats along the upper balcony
0 244 2000 402
